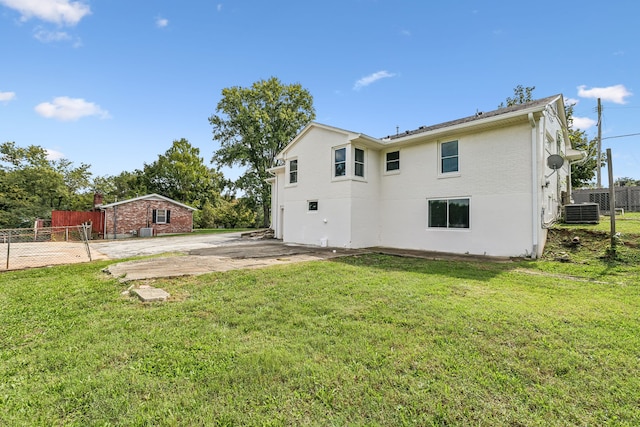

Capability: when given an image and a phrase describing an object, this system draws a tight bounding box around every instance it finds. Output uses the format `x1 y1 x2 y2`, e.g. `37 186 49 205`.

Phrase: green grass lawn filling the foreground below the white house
0 219 640 426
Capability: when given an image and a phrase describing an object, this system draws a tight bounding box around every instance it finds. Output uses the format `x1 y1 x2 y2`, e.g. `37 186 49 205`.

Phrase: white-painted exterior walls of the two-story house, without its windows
273 98 569 256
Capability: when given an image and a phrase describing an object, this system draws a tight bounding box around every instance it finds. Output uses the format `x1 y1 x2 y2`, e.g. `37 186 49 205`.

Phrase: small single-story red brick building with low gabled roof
96 194 196 239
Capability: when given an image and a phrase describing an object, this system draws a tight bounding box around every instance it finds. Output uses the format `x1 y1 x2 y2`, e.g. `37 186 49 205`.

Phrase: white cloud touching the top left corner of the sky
0 0 91 26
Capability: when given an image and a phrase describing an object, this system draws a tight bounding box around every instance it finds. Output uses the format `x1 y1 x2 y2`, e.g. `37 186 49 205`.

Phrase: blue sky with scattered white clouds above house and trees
0 0 640 185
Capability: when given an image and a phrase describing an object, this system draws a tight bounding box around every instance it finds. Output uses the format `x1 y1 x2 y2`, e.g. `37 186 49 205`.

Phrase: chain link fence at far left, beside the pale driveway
0 224 92 271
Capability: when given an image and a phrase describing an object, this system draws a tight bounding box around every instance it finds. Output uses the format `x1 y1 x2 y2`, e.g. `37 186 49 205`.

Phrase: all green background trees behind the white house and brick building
0 82 608 232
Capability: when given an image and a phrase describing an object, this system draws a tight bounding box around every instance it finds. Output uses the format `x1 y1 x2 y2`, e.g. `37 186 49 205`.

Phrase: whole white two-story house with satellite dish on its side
270 95 581 258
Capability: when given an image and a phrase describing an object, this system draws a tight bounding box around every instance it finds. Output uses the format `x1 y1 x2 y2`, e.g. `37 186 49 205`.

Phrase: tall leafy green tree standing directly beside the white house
209 77 315 227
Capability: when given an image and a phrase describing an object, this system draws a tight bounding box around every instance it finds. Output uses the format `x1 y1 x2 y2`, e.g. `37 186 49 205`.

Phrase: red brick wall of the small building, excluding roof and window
105 200 193 239
